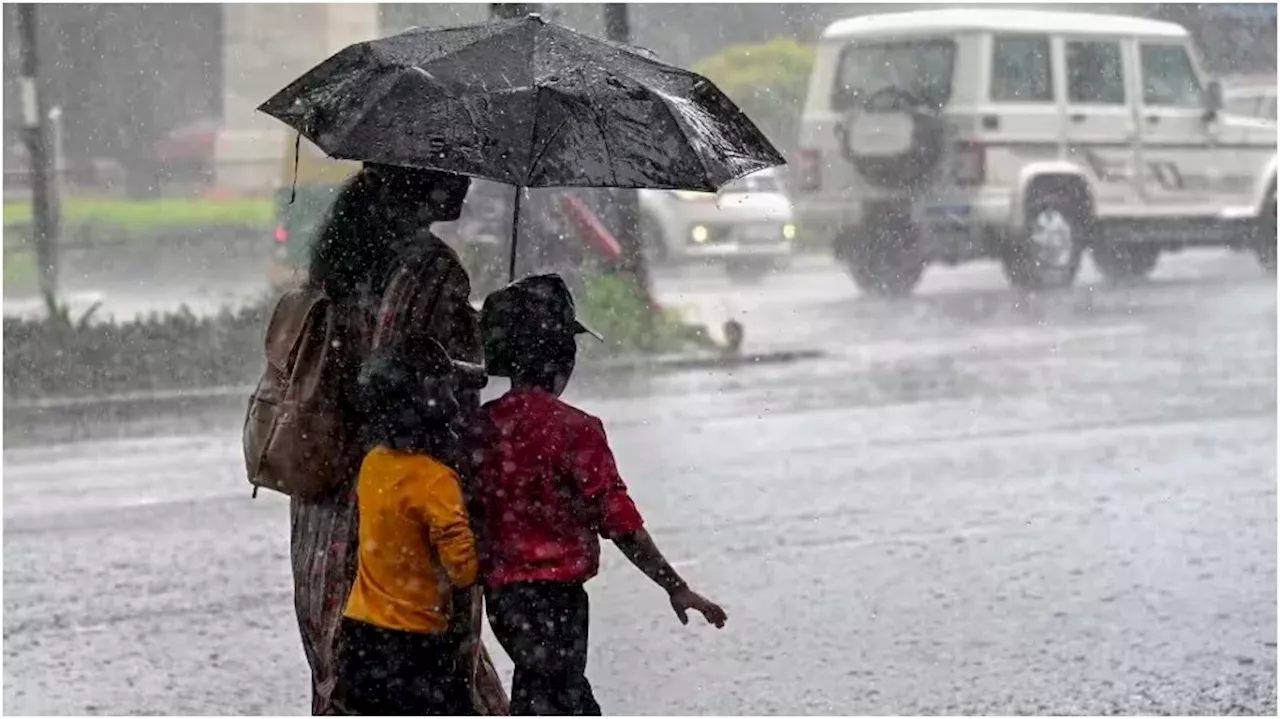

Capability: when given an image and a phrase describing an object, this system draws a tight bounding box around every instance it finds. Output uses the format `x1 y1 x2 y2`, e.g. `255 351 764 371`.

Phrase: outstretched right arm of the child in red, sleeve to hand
568 418 727 627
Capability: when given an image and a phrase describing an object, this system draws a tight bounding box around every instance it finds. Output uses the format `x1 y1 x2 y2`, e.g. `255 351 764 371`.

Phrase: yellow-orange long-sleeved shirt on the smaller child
343 446 479 633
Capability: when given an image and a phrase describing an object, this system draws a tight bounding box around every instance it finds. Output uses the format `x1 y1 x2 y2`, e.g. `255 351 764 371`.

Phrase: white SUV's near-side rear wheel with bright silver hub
1004 191 1088 289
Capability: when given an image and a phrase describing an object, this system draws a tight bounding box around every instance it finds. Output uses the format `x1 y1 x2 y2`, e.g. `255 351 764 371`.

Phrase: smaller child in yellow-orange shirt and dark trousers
333 343 479 715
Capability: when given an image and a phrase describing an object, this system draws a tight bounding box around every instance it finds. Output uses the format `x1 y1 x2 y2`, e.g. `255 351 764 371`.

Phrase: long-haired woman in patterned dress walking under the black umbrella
291 165 507 715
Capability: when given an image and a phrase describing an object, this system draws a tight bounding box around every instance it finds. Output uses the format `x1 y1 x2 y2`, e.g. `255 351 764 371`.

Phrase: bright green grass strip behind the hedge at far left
4 198 275 232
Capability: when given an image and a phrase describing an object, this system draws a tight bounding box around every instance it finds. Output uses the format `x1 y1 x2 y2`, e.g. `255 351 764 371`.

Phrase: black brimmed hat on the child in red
480 274 604 376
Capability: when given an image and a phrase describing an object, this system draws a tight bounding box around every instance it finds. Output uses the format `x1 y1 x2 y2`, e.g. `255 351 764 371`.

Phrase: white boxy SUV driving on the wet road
794 9 1276 294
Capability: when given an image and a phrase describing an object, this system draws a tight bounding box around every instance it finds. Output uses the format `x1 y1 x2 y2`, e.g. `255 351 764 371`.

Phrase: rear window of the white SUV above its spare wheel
832 38 955 107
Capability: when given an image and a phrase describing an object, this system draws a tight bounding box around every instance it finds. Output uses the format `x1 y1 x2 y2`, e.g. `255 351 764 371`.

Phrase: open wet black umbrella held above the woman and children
259 15 785 279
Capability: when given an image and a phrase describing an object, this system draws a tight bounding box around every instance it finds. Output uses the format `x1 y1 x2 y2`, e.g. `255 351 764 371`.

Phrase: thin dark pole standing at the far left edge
18 3 58 312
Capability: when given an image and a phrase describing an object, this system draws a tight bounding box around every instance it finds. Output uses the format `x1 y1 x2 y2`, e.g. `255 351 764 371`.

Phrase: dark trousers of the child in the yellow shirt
333 618 475 716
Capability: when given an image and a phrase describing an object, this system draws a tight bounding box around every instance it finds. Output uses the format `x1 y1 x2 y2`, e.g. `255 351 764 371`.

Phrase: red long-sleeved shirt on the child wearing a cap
471 390 644 587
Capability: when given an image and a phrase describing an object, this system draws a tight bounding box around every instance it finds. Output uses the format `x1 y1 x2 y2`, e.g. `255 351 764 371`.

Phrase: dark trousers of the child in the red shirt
485 582 600 716
